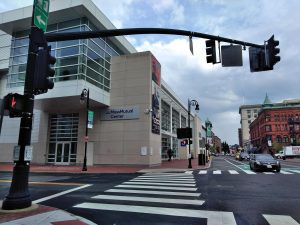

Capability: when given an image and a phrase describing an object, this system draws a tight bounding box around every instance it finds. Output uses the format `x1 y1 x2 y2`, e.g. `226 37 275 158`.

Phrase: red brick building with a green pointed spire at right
250 95 300 151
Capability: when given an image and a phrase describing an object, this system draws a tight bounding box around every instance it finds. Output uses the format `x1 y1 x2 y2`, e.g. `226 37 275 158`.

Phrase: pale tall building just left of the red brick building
239 104 261 149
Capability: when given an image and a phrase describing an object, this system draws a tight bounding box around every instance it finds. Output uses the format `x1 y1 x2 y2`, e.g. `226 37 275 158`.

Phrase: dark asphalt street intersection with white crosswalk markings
0 156 300 225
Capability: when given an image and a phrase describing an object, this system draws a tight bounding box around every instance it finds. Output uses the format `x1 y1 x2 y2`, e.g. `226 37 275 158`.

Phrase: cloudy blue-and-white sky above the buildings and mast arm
0 0 300 144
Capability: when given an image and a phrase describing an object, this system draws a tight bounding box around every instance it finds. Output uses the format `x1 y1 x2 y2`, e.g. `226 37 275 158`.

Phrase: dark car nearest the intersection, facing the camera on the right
249 154 281 173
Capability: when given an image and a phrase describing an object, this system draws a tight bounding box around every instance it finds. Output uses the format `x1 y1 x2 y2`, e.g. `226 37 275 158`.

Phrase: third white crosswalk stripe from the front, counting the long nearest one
105 189 201 197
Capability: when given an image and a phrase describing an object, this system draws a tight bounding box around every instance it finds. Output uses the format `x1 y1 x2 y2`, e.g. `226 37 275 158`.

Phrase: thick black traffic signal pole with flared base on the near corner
2 4 47 210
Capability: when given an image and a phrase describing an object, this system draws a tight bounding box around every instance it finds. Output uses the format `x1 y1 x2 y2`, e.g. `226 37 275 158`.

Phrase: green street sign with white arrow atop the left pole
33 0 49 31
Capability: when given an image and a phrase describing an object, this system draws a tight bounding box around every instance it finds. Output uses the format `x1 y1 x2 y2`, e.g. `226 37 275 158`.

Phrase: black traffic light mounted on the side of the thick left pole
33 46 56 95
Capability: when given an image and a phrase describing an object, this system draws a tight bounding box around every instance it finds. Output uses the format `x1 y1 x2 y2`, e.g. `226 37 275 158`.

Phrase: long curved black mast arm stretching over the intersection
45 28 264 48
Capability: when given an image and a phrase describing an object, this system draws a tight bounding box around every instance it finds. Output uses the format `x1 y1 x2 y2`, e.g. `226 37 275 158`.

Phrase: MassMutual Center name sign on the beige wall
100 106 140 120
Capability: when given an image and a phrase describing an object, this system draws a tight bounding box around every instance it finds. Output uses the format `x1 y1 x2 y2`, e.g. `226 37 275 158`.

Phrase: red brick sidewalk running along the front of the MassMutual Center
0 159 210 173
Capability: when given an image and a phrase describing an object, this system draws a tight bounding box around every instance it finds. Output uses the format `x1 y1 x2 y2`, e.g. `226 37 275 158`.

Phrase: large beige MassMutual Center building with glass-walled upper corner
0 0 202 166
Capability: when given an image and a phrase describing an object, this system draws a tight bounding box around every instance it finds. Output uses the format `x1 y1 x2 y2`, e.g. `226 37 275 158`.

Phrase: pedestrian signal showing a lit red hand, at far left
3 93 25 117
